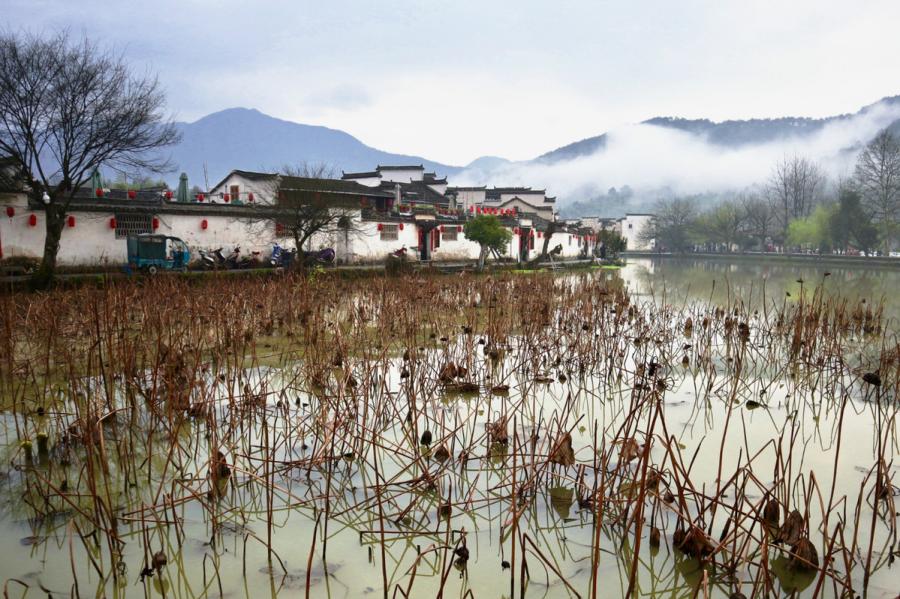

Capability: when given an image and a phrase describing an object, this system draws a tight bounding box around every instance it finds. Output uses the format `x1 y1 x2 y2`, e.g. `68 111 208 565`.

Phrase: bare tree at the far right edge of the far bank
854 129 900 253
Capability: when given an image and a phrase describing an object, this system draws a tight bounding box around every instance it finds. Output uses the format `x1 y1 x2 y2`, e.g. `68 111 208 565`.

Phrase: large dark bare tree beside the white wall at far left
0 33 178 284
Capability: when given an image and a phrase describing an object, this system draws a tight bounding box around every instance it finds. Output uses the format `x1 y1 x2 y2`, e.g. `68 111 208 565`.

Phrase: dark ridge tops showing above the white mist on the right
535 96 900 164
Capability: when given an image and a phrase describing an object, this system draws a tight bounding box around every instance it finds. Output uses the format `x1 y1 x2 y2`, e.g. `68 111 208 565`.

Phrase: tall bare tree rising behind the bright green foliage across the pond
768 155 825 236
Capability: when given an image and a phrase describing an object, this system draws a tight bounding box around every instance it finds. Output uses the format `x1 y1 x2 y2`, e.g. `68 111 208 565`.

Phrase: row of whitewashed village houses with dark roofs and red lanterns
0 165 594 265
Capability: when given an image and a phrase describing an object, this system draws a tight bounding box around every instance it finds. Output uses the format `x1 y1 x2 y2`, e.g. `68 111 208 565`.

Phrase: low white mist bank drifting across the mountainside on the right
454 103 900 205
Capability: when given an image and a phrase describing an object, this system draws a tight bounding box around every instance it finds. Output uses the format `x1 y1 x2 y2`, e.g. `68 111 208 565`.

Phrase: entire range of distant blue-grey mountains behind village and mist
162 96 900 199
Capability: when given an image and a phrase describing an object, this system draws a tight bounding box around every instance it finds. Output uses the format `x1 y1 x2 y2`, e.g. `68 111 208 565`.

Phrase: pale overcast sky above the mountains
7 0 900 164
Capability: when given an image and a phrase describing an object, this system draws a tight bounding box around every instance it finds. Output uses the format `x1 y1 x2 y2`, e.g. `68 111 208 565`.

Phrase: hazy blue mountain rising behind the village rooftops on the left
169 108 461 187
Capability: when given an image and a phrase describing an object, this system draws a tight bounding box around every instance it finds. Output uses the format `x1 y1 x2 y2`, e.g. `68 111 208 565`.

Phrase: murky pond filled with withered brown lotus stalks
0 270 898 598
